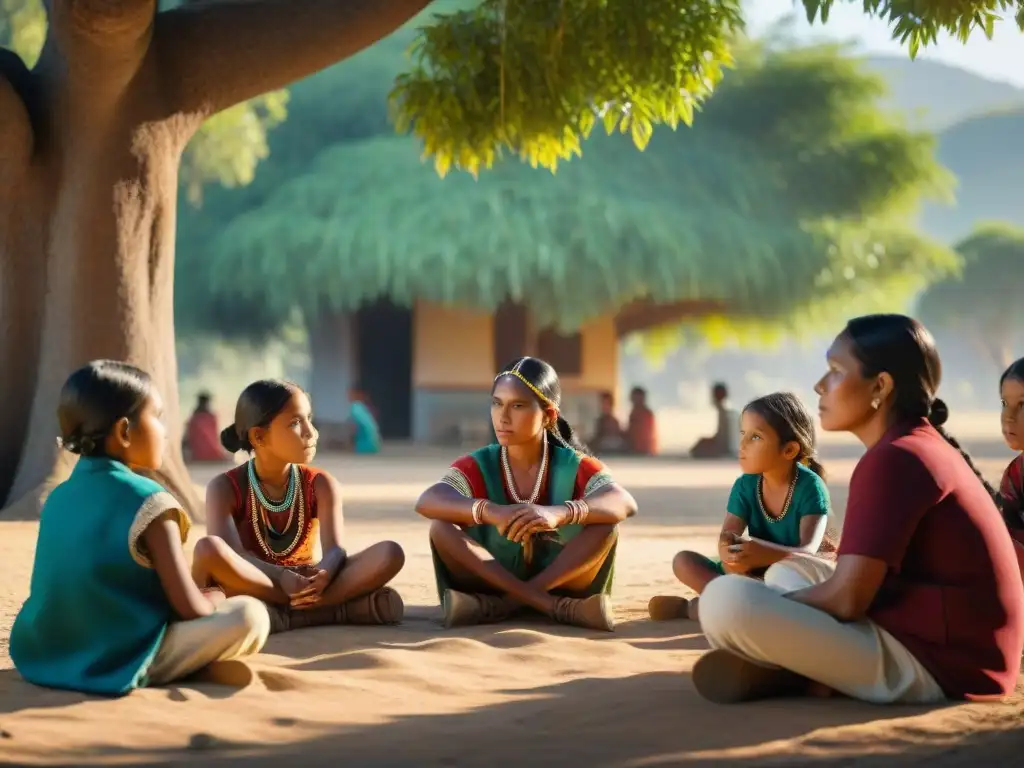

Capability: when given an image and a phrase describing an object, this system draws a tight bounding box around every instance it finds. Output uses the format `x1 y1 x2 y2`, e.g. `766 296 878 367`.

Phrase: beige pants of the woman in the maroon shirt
700 555 945 703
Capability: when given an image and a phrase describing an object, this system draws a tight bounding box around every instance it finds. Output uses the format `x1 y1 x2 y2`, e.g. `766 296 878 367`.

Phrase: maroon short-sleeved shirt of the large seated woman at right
840 421 1024 699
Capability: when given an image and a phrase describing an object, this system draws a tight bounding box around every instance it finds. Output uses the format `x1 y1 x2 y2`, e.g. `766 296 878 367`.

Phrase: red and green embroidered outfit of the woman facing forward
431 444 615 599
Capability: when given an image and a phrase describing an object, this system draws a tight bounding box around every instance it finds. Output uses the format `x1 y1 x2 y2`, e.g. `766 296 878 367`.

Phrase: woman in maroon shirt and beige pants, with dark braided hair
693 314 1024 703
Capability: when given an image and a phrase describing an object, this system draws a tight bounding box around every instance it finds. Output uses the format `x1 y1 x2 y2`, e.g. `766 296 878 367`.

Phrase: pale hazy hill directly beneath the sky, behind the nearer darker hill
863 56 1024 132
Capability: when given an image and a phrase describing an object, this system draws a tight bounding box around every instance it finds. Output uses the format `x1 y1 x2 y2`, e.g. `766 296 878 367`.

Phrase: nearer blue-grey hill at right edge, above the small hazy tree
922 105 1024 243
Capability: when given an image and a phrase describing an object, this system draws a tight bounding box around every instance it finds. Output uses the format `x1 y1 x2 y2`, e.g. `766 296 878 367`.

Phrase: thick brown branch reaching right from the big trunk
155 0 430 116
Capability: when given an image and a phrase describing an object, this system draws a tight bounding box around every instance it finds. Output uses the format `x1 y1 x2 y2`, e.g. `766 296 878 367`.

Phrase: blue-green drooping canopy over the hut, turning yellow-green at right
178 45 955 329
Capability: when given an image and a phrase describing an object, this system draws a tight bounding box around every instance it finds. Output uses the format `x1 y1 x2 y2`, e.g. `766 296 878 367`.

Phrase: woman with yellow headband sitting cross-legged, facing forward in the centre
416 357 637 631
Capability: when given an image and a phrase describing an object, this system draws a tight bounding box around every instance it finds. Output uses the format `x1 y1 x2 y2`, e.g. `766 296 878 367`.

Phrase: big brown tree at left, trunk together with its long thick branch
0 0 427 517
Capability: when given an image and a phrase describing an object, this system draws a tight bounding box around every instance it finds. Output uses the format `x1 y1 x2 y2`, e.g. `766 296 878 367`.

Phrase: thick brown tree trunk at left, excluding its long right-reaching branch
0 4 199 517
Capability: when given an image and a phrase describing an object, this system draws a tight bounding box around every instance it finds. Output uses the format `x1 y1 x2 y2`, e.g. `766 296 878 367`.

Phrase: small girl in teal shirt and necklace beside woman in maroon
648 392 836 621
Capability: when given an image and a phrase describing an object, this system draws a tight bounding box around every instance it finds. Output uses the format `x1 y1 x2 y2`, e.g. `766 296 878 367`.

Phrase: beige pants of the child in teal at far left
150 597 270 685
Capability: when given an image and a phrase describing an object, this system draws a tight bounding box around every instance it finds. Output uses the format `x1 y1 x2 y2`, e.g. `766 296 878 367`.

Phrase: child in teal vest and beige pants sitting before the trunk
10 360 269 695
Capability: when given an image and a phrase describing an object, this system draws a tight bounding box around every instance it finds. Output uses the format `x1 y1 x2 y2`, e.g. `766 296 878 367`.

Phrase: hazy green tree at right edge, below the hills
918 222 1024 371
